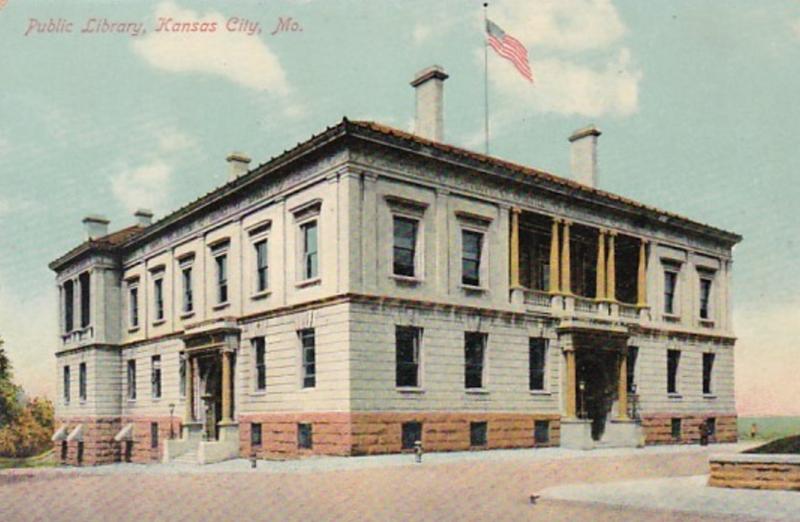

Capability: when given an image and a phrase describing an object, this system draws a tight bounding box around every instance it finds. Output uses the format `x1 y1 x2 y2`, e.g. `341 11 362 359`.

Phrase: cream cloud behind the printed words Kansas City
132 2 289 96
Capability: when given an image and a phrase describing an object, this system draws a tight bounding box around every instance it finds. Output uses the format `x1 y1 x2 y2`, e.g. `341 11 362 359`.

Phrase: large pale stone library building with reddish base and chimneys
50 67 741 464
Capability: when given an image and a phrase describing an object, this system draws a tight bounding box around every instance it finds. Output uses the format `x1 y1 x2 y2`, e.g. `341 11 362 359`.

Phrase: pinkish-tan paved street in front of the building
0 440 776 522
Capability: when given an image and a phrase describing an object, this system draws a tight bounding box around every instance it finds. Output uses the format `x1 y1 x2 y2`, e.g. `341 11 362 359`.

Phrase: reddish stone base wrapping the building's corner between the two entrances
239 412 560 458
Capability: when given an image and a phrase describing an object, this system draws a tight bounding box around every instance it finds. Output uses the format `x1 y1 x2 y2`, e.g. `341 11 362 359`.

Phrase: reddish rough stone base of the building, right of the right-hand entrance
642 413 738 445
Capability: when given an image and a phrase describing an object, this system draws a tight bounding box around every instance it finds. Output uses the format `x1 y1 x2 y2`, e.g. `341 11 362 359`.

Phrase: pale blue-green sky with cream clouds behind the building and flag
0 0 800 415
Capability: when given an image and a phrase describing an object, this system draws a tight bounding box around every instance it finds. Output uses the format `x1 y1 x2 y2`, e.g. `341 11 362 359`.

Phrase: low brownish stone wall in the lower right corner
708 454 800 491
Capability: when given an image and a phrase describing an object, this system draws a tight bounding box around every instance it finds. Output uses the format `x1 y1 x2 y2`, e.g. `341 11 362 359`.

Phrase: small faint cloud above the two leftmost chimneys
111 160 173 213
